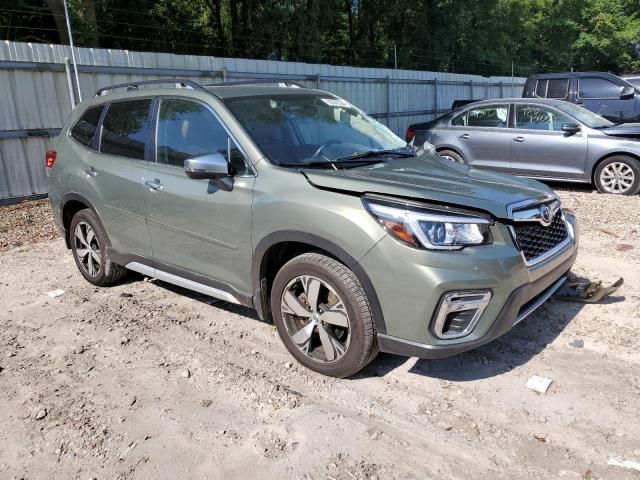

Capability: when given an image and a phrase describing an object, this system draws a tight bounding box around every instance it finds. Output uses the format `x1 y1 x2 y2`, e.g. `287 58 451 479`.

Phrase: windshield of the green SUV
226 94 413 166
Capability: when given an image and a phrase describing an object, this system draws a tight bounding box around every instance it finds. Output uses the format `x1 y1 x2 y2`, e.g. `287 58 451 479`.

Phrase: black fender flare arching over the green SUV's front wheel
251 230 387 333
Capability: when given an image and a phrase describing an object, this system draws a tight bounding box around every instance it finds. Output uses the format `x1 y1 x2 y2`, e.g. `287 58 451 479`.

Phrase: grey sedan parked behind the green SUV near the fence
407 98 640 195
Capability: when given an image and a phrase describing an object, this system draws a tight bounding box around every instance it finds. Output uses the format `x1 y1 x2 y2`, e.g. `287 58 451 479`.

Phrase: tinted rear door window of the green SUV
100 99 151 160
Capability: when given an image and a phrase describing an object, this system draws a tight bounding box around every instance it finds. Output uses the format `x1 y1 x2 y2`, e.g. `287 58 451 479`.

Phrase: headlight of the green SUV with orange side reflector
362 197 493 250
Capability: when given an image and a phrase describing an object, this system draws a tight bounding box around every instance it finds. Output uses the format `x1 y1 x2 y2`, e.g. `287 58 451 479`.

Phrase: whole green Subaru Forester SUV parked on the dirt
46 80 578 377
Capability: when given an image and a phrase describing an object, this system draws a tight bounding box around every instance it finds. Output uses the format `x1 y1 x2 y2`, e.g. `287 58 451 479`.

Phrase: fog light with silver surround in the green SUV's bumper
432 291 491 340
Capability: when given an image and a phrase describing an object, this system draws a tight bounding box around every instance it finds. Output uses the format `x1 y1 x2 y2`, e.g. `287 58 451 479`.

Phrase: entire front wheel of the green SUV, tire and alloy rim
271 253 378 378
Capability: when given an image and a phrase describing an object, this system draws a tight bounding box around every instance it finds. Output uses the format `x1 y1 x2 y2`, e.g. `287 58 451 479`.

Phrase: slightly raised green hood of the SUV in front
302 155 555 218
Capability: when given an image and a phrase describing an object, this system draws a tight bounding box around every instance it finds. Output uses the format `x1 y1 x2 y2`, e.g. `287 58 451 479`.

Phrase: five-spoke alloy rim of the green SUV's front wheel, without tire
280 275 351 363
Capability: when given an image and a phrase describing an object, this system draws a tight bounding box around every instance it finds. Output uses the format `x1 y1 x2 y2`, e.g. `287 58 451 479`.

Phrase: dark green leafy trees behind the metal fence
0 0 640 75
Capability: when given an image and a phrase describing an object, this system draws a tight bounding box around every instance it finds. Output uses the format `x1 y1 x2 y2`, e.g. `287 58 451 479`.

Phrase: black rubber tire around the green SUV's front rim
271 253 378 378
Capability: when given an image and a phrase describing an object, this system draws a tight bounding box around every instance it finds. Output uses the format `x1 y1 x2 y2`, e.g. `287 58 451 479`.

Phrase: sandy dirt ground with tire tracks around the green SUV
0 186 640 480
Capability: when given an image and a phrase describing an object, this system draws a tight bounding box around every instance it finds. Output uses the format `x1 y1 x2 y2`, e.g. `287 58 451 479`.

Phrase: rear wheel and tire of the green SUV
69 208 127 287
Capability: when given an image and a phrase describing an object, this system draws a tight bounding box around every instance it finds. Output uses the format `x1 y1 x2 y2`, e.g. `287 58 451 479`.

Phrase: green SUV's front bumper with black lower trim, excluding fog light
360 215 579 358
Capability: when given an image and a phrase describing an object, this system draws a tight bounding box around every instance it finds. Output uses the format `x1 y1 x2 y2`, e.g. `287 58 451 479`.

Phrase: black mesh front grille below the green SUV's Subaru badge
513 210 568 262
